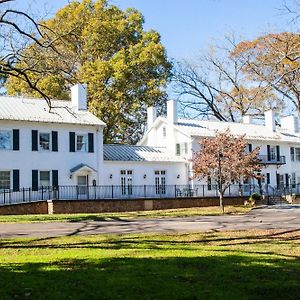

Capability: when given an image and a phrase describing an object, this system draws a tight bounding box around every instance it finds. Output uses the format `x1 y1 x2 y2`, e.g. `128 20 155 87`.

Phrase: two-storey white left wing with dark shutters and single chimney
0 85 105 190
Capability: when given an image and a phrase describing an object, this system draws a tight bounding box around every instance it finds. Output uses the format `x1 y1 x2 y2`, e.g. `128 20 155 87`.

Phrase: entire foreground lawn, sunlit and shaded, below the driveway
0 230 300 300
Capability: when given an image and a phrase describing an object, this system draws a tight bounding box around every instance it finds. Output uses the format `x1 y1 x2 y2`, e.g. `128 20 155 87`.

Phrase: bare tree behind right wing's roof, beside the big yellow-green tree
173 38 279 122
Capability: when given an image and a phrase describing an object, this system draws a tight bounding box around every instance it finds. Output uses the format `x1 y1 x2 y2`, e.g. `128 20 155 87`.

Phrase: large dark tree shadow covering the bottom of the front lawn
0 255 300 300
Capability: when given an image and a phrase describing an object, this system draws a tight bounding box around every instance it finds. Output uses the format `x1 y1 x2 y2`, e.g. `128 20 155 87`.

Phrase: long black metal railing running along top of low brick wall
0 184 300 205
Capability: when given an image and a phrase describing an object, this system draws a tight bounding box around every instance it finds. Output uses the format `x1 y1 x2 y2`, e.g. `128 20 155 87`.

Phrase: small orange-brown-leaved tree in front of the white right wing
193 130 261 213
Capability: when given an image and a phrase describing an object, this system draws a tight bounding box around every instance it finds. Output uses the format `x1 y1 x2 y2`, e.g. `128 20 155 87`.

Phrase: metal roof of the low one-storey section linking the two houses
103 144 185 162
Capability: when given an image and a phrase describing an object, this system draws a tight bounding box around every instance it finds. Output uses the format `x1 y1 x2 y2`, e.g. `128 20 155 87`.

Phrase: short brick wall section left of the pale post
0 201 48 215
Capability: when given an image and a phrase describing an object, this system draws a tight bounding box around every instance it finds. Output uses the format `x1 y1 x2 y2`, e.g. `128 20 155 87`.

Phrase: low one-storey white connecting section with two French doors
103 145 189 197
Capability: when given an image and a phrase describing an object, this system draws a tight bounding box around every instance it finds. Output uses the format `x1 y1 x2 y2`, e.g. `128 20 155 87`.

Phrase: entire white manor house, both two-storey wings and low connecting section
0 84 300 202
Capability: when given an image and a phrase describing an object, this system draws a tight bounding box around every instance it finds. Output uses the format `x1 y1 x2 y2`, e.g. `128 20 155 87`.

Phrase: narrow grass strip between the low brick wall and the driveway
0 206 251 223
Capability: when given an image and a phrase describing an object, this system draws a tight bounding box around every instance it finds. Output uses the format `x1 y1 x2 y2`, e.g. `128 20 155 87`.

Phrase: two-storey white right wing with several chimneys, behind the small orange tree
139 100 300 190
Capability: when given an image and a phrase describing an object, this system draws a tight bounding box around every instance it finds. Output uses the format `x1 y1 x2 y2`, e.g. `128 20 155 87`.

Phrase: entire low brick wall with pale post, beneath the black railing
0 197 252 215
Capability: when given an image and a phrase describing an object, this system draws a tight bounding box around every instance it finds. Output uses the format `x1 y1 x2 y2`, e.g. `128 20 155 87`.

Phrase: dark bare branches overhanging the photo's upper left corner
0 0 65 108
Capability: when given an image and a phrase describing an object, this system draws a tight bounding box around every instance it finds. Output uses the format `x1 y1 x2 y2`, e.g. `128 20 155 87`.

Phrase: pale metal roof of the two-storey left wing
0 97 105 126
